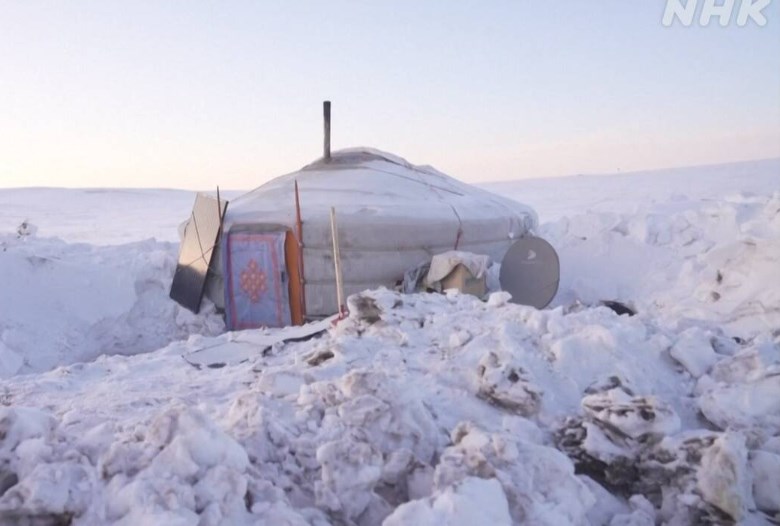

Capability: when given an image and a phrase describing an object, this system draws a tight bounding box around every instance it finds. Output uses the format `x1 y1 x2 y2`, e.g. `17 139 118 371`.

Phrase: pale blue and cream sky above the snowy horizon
0 0 780 189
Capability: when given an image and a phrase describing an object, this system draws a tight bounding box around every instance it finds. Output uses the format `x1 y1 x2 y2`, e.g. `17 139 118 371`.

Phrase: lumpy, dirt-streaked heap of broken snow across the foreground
0 290 780 525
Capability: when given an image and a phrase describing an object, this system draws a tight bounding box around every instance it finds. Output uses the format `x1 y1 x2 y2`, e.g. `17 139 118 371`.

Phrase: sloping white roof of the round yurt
225 148 537 230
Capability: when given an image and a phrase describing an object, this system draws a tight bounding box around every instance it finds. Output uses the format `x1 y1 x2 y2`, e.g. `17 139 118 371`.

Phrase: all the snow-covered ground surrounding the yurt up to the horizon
0 160 780 526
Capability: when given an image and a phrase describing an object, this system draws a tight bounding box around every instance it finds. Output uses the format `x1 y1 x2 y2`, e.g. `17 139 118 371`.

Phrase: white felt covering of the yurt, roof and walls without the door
209 148 537 318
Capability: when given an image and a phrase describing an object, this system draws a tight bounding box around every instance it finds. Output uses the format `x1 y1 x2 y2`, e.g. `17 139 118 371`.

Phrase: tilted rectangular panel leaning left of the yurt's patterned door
170 194 228 314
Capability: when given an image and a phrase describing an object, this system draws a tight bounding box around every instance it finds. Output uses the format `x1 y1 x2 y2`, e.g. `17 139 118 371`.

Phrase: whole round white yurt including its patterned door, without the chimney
206 148 537 329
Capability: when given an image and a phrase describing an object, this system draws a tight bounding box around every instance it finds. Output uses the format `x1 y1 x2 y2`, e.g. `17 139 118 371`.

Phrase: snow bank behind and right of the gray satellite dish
541 192 780 340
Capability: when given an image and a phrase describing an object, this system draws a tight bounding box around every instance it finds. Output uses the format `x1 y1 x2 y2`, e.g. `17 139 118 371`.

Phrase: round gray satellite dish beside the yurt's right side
498 236 561 309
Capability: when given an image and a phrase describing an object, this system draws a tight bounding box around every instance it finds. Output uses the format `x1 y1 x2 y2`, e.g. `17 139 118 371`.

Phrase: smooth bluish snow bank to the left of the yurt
0 235 224 378
